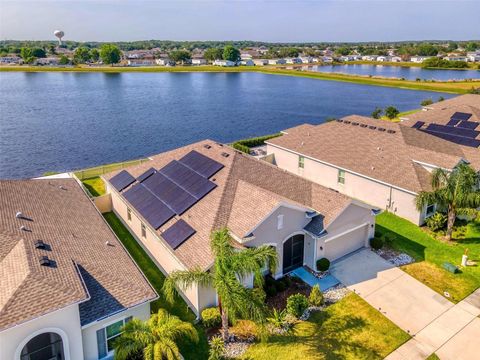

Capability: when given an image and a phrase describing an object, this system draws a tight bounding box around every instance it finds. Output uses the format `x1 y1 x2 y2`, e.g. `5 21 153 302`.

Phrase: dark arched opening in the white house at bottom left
20 332 65 360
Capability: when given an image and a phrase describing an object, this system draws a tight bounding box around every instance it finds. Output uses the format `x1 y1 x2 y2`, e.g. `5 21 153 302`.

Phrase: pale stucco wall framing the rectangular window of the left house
82 302 150 360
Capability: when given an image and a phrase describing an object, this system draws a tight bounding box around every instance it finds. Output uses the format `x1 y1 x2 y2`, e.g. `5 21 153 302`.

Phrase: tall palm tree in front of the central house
163 229 277 341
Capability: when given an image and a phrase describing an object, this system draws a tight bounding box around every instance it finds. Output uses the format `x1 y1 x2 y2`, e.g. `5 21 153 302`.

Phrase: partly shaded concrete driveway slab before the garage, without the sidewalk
331 249 454 335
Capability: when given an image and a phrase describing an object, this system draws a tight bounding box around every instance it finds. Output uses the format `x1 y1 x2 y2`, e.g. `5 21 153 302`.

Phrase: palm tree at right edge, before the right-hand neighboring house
415 164 480 240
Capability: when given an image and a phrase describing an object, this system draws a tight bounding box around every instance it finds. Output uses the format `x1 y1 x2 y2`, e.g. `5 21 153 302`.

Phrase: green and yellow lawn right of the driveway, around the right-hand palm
376 212 480 302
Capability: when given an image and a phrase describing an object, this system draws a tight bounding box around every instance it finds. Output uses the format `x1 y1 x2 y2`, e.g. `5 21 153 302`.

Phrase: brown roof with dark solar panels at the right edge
401 94 480 151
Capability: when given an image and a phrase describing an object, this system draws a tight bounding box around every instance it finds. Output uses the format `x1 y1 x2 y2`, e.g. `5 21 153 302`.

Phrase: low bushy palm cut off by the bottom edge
114 309 198 360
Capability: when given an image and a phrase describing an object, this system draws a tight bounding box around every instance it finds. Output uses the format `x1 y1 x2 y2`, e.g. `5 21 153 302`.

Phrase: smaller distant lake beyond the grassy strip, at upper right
301 64 480 81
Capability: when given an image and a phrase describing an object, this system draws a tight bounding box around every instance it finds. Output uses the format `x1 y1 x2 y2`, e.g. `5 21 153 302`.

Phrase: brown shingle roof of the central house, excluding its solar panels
104 140 351 269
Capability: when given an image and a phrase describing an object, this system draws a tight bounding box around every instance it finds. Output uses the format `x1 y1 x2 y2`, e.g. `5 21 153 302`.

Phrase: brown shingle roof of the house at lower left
0 179 156 329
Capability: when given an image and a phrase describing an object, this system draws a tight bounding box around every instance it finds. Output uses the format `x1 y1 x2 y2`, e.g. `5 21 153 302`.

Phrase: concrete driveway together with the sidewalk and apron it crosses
332 250 480 360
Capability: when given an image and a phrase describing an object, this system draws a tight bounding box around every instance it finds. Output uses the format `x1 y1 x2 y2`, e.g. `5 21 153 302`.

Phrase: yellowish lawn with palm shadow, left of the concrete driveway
243 293 410 360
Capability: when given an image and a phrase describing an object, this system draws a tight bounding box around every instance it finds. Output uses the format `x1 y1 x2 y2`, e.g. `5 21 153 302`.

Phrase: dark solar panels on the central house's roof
120 150 223 249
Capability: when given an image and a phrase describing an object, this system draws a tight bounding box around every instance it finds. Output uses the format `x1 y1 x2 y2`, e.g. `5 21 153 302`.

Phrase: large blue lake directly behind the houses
0 72 454 178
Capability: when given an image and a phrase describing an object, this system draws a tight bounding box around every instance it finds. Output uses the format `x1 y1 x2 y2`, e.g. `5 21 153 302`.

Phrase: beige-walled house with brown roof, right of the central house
266 115 480 224
